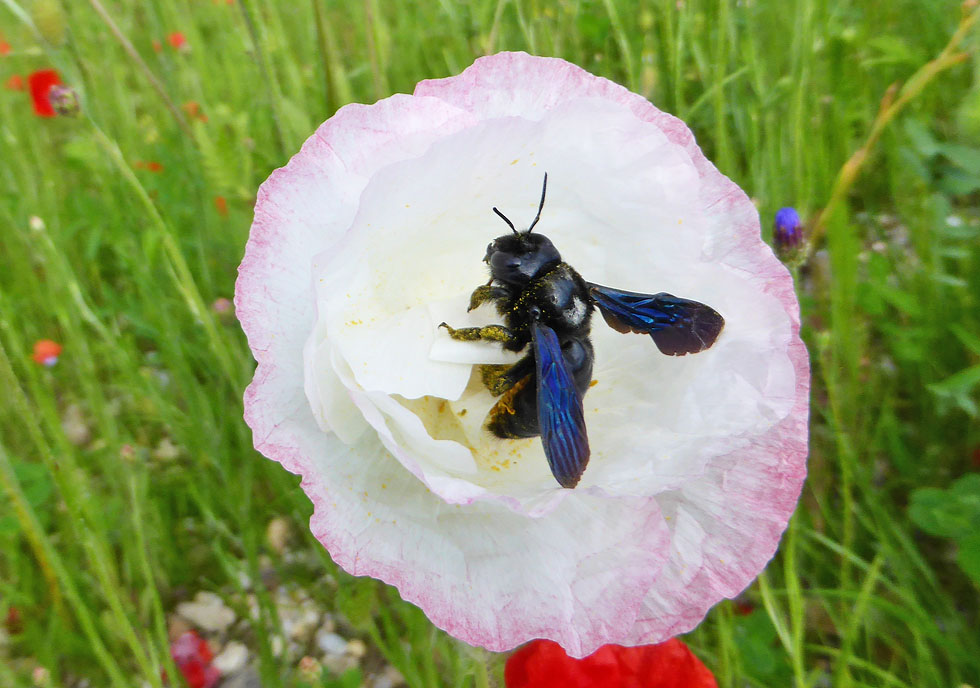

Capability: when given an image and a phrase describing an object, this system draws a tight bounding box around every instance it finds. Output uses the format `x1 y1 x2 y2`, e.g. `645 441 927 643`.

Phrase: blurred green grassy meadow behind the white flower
0 0 980 688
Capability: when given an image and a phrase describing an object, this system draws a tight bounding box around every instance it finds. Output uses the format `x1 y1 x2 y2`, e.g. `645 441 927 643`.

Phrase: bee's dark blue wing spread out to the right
589 282 725 356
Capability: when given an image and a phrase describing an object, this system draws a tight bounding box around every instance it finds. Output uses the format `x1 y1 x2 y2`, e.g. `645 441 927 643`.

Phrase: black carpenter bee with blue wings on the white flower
440 174 725 488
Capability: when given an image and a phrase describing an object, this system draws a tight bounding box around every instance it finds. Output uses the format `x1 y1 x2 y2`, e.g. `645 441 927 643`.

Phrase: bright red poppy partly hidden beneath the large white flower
504 638 718 688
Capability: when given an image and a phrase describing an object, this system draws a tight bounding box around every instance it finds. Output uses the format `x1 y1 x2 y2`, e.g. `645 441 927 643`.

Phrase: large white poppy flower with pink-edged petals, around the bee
236 53 809 656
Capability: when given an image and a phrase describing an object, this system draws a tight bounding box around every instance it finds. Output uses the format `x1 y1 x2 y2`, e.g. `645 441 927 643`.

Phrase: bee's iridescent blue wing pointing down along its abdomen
531 321 589 487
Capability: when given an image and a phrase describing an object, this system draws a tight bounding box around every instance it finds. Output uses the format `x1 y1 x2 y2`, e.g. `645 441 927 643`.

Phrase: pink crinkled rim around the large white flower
235 53 809 656
